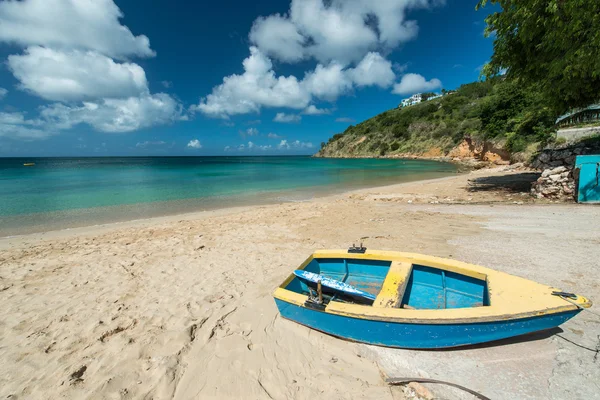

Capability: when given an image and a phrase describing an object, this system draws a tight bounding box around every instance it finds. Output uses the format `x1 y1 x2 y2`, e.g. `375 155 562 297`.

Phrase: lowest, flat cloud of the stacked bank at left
40 93 185 133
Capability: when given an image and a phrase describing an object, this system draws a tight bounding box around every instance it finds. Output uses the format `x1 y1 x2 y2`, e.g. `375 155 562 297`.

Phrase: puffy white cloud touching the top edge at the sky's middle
249 0 444 64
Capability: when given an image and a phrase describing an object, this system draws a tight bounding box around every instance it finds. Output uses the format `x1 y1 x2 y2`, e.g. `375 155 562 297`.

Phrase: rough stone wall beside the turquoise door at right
530 140 600 200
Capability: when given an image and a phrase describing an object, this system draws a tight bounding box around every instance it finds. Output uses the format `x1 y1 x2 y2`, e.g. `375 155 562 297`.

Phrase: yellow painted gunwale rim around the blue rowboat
273 250 592 324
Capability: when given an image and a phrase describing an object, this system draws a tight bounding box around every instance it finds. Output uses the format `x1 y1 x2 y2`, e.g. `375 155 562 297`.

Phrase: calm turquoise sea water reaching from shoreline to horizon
0 157 457 237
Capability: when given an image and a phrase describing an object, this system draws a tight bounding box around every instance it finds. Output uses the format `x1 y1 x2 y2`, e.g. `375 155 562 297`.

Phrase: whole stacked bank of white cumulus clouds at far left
0 0 187 139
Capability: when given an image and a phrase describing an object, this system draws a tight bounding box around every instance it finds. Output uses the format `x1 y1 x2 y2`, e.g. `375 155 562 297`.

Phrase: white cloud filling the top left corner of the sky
0 0 155 59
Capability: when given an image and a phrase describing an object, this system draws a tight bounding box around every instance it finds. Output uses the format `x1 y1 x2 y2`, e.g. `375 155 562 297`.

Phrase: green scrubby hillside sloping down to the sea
317 77 556 157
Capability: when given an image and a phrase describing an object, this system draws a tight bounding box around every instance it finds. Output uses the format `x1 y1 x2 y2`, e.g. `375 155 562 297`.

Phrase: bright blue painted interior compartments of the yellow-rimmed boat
285 258 490 309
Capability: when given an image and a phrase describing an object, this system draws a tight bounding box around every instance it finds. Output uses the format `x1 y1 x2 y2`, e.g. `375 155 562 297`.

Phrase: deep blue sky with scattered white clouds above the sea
0 0 492 156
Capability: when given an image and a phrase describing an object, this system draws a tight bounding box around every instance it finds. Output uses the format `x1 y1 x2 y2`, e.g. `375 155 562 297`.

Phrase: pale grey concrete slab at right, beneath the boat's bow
361 205 600 400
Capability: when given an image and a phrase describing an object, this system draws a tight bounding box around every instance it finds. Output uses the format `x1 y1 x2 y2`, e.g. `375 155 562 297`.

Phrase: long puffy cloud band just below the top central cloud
195 46 395 119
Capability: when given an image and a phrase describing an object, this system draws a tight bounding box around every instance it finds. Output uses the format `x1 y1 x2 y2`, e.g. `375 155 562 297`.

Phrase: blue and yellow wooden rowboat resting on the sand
273 248 592 349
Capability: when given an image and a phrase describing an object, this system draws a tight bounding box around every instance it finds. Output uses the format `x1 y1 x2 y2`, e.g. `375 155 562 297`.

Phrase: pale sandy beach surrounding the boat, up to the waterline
0 168 600 399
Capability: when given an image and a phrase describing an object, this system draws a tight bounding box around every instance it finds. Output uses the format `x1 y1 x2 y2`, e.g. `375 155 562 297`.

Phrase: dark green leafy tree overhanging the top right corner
477 0 600 113
